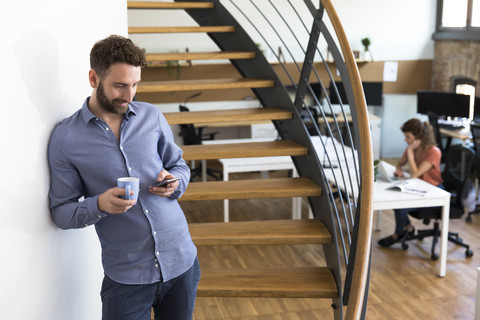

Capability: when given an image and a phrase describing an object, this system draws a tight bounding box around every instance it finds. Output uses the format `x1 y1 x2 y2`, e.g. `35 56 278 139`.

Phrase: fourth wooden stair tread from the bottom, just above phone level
180 140 308 161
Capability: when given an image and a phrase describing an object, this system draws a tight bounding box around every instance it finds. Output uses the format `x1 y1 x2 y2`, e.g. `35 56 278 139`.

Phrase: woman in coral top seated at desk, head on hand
378 118 443 247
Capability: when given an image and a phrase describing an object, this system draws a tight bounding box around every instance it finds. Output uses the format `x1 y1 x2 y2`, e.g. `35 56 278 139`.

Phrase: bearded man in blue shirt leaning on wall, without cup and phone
48 36 200 320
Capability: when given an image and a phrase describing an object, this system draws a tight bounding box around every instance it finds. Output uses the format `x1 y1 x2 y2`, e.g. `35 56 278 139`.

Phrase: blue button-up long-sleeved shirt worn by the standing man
48 98 197 284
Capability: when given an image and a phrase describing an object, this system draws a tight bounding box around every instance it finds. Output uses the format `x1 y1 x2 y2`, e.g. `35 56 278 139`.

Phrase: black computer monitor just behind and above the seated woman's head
417 90 470 118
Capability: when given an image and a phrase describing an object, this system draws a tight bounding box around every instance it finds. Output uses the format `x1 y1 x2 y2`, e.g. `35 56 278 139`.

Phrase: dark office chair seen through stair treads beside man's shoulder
179 101 223 181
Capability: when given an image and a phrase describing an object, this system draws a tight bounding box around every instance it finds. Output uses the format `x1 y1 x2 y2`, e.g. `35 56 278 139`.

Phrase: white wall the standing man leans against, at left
0 0 127 320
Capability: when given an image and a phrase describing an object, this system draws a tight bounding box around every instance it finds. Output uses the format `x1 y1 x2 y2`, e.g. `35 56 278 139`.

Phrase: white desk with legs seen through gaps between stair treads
202 139 302 222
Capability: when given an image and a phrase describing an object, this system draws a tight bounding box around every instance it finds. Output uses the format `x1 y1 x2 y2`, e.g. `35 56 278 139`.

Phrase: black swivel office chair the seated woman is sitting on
402 145 475 261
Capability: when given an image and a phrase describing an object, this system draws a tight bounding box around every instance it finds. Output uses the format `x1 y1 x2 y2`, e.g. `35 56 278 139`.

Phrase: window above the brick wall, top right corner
433 0 480 40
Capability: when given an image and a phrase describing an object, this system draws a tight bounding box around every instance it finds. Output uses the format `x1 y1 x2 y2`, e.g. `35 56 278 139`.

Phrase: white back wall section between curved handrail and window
332 0 437 61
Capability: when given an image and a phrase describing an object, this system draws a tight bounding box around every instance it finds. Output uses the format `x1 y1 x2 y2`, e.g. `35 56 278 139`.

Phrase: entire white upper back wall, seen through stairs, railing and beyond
128 0 436 63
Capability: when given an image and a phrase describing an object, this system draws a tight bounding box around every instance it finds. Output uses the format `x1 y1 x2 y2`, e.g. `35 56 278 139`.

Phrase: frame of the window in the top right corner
432 0 480 40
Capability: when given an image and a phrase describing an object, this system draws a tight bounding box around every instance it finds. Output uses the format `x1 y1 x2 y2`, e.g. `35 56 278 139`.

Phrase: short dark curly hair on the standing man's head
90 35 146 78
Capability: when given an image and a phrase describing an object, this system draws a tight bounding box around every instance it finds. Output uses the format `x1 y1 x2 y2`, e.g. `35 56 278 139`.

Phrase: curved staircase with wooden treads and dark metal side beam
128 1 374 319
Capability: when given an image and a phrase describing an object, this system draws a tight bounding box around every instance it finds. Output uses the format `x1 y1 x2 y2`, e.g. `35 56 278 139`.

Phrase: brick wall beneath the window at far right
432 40 480 92
